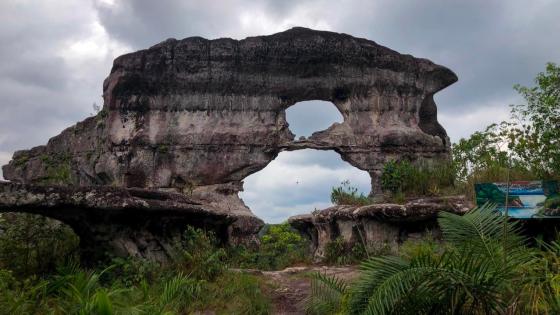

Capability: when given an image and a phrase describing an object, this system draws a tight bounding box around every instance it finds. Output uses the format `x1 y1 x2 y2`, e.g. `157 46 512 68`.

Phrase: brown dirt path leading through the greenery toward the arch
249 266 357 315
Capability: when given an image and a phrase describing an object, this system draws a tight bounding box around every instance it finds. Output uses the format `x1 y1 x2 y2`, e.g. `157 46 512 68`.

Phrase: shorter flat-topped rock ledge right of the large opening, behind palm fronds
288 196 473 259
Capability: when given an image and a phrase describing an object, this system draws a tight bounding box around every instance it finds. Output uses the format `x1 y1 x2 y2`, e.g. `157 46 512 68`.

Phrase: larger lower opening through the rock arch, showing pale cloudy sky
240 149 371 223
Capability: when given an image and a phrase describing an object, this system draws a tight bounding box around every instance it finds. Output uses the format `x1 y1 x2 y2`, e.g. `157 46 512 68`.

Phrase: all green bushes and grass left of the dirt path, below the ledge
0 214 269 315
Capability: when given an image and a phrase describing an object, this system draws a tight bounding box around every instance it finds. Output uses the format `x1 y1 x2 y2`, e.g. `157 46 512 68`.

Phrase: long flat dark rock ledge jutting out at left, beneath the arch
0 182 263 263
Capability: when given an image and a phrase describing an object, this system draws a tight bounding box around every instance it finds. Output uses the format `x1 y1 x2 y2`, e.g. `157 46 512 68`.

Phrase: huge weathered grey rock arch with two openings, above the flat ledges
3 28 457 260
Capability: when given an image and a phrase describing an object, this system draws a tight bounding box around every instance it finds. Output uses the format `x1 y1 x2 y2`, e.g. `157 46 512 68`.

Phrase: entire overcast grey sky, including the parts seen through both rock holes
0 0 560 221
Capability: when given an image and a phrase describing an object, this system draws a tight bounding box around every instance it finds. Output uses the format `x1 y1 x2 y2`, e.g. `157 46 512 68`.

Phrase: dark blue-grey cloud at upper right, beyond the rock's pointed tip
332 0 560 129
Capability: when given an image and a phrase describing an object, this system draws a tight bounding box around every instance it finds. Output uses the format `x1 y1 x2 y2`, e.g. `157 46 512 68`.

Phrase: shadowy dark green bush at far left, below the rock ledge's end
0 212 80 276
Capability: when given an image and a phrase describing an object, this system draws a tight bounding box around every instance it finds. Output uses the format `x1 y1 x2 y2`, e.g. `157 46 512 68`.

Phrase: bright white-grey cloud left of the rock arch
0 0 127 178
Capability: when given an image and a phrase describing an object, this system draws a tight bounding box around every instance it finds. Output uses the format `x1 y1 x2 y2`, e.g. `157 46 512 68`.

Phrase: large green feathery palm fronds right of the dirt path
308 206 560 314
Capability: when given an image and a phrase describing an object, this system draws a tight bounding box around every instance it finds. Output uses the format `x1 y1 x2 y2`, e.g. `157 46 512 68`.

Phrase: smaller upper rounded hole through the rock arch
286 101 344 140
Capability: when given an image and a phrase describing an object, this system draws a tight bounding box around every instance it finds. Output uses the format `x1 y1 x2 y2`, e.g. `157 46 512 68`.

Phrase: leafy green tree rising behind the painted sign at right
452 63 560 184
